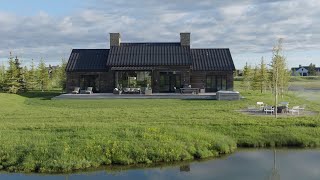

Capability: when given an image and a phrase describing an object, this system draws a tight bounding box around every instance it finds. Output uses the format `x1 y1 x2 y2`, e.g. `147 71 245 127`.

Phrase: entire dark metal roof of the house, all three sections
66 43 235 72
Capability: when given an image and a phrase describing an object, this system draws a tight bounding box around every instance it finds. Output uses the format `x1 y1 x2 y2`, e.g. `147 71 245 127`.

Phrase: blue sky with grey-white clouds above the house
0 0 320 68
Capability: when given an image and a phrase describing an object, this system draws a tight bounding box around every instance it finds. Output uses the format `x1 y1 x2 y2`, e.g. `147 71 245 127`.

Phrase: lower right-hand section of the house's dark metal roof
191 49 235 71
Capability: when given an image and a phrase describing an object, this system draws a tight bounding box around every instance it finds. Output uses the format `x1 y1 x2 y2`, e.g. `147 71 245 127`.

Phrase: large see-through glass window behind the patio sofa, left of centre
115 71 151 88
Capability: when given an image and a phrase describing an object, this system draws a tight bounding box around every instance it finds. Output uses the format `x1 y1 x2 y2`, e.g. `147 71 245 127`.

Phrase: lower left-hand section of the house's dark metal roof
66 49 109 72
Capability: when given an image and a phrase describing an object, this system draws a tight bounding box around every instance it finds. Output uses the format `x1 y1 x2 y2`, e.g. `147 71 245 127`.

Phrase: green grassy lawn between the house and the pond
0 80 320 172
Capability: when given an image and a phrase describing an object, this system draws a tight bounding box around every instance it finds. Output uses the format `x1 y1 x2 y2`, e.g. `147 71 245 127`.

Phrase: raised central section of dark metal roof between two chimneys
106 43 192 66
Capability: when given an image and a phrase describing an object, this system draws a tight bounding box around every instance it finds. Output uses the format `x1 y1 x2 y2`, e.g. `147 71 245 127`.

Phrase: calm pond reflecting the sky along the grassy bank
0 149 320 180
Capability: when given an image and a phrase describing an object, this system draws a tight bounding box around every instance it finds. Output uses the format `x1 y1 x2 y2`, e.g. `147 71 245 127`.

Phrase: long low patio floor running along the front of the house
52 93 216 100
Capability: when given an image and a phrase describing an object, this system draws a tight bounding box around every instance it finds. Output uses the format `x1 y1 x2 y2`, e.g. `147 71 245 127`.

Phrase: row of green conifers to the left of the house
0 53 67 94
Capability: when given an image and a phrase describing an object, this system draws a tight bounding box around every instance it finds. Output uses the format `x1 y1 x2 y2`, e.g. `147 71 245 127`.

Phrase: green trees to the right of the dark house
242 39 291 94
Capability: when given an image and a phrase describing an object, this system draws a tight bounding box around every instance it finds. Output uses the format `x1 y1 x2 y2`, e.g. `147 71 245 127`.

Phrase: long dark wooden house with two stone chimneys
66 33 235 93
